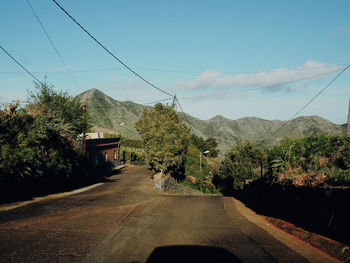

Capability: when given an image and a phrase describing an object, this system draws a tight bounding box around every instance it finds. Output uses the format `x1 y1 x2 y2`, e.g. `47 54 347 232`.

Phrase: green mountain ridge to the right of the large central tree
187 115 345 150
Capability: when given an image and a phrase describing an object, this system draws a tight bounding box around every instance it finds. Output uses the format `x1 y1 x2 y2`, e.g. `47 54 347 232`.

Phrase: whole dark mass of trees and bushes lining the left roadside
0 84 87 201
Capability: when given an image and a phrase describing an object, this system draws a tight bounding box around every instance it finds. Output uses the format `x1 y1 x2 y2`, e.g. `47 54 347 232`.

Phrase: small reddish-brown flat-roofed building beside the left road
85 137 120 166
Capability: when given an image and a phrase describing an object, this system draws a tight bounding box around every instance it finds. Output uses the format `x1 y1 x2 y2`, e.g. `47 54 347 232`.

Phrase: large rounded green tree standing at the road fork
136 103 190 178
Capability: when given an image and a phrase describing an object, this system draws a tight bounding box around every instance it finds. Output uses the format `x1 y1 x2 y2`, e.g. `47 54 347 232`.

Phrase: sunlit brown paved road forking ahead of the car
0 167 340 262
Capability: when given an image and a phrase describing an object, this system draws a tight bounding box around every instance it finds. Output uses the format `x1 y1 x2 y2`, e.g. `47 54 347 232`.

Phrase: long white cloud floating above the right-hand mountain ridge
176 60 344 90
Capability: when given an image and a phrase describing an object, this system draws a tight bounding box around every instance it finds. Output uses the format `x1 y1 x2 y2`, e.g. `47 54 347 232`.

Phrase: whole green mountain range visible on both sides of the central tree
78 89 346 152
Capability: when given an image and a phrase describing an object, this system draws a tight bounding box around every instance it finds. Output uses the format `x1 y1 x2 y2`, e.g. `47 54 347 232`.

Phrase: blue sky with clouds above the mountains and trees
0 0 350 124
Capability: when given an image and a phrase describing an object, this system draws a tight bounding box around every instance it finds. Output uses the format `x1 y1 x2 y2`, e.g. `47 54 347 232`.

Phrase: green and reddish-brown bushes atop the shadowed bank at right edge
269 135 350 185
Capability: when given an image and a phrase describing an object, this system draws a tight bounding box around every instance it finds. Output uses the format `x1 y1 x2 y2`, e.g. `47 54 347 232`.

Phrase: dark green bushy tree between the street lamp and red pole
213 142 261 194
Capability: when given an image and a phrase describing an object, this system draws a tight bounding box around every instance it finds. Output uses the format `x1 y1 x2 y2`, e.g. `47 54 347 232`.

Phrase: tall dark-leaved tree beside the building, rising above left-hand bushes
27 83 89 183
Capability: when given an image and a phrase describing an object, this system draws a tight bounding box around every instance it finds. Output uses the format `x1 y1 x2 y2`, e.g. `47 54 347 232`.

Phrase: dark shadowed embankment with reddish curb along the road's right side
237 180 350 260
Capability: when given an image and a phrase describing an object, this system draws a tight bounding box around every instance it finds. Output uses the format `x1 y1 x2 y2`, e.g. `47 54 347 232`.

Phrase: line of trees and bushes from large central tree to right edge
136 104 350 194
